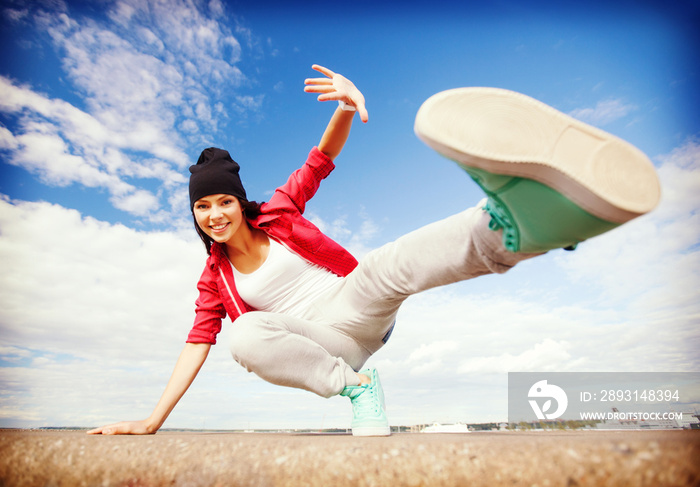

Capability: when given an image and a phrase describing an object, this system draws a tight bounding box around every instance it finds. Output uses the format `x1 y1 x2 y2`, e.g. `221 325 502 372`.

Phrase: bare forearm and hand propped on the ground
88 343 211 435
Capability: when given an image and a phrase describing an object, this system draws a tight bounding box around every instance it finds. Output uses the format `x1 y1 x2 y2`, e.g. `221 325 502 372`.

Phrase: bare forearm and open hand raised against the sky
304 64 369 159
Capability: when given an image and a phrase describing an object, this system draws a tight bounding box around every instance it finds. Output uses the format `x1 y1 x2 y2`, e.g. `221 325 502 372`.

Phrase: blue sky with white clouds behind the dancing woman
0 0 700 428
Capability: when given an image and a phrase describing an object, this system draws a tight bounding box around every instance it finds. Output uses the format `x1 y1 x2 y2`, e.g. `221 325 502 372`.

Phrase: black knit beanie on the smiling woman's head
190 147 248 209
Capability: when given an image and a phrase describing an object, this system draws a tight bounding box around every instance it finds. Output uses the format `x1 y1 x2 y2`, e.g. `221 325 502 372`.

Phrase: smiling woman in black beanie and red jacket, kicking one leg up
89 65 658 436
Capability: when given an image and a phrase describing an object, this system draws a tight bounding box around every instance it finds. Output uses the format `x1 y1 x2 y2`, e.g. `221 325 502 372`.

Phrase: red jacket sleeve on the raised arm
268 147 335 213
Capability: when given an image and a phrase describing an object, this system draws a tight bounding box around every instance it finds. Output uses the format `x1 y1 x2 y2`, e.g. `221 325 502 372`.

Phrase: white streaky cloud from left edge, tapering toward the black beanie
0 81 178 216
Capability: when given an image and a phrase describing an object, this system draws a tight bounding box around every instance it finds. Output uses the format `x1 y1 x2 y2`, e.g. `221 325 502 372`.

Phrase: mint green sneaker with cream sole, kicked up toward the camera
415 88 660 252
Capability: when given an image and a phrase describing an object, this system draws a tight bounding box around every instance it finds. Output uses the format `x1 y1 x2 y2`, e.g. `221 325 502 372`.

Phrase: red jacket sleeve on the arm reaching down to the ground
187 264 226 345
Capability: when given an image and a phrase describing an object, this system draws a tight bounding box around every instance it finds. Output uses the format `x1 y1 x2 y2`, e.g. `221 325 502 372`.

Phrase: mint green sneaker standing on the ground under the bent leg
340 369 391 436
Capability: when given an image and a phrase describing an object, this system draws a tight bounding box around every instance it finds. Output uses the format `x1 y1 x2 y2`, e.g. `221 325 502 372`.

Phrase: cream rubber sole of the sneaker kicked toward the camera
415 88 660 224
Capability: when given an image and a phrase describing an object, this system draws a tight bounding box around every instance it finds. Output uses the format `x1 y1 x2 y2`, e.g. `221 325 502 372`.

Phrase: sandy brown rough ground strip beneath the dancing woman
0 430 700 487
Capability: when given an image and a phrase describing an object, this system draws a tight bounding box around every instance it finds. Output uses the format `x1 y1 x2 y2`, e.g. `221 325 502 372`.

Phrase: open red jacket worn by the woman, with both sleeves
187 147 357 344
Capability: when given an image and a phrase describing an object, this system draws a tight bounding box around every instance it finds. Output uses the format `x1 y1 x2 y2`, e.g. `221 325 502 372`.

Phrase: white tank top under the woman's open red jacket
231 239 343 317
